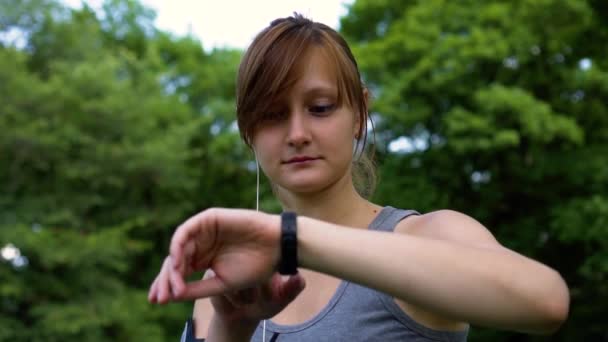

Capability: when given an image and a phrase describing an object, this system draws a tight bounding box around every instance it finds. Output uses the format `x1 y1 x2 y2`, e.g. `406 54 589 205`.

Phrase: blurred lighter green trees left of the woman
0 0 255 341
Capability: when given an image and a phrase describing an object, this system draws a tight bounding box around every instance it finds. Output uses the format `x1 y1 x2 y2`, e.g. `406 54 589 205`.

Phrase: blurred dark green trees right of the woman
341 0 608 341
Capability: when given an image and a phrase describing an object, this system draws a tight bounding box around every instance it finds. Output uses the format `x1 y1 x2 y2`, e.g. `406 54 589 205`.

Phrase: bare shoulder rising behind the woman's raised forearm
395 209 502 249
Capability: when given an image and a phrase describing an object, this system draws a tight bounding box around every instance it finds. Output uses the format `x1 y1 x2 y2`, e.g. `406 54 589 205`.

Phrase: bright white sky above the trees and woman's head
64 0 353 50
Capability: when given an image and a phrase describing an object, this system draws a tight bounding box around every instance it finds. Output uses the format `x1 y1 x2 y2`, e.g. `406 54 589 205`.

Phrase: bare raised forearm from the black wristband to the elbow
298 217 565 332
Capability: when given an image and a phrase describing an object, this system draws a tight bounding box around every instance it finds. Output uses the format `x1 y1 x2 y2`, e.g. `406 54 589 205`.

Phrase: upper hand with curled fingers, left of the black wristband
148 209 280 303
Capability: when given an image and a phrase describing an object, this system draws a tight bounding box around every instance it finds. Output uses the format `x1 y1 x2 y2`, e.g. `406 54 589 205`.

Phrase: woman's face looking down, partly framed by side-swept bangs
253 49 359 193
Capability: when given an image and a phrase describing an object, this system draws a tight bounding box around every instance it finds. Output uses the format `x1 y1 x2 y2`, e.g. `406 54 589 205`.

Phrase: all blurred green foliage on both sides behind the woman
0 0 608 341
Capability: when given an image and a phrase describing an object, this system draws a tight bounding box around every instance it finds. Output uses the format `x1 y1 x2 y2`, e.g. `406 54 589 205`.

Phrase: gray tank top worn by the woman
182 207 468 342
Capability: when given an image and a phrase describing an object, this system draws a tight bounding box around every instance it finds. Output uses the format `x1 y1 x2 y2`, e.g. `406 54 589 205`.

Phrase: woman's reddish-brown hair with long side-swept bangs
236 13 376 197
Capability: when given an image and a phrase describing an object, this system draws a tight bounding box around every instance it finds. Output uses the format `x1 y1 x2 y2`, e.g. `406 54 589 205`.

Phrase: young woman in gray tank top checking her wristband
149 15 569 341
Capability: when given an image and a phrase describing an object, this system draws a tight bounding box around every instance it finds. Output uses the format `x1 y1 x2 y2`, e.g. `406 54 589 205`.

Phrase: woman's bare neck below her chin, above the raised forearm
276 174 380 229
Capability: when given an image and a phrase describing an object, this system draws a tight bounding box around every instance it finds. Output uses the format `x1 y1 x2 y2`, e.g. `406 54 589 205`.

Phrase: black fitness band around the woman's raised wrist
279 211 298 275
